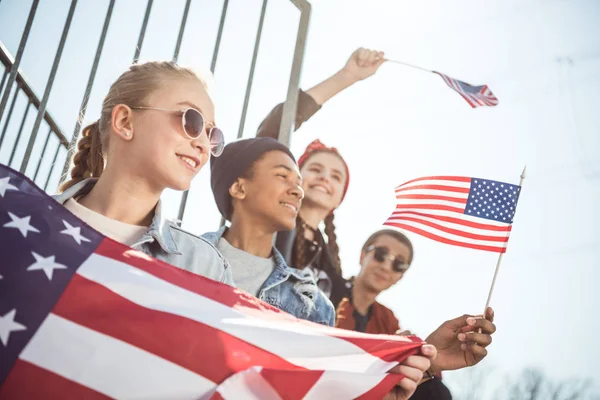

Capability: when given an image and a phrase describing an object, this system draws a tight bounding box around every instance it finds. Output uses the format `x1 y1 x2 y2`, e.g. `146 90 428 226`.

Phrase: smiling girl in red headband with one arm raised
257 48 385 305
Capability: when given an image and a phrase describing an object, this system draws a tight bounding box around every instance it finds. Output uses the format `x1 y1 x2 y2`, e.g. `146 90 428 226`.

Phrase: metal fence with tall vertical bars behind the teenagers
0 0 311 225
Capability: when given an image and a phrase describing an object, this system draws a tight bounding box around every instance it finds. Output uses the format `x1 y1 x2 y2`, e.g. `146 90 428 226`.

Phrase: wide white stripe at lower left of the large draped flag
20 314 216 399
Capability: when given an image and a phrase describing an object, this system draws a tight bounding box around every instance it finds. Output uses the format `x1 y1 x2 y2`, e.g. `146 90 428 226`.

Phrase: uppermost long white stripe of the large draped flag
77 254 397 373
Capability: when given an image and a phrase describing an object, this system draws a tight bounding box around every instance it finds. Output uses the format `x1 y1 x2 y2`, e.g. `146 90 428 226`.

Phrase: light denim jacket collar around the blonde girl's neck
54 178 181 254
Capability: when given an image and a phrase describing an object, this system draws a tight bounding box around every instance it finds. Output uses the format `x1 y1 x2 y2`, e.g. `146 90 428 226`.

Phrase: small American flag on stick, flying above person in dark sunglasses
384 176 521 253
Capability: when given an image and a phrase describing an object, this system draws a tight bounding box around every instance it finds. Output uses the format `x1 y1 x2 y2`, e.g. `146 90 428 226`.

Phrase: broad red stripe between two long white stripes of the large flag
52 274 301 382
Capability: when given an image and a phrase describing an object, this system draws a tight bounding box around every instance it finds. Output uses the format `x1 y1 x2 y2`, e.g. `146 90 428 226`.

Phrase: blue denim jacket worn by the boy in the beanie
202 227 335 326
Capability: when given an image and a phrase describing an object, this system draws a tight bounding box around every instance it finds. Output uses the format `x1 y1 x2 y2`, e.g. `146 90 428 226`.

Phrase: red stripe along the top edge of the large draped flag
96 239 420 361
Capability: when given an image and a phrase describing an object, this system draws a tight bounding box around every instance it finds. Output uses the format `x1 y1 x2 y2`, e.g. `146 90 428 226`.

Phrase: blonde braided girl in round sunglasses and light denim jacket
55 62 233 284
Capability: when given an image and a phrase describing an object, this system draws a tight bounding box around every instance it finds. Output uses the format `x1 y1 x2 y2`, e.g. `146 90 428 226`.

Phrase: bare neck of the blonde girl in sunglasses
79 165 162 226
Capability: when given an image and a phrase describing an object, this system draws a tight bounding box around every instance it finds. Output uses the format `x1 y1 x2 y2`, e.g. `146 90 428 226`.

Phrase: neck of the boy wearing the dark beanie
223 213 275 258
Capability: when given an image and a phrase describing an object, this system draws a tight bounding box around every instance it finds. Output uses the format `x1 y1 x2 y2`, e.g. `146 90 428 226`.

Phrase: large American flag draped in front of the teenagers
0 164 422 400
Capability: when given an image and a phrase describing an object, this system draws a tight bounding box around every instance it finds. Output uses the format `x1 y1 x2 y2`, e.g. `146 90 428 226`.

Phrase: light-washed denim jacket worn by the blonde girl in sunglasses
53 178 233 286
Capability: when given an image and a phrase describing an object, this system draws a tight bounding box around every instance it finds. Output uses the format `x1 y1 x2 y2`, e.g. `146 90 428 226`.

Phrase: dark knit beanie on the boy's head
210 137 296 220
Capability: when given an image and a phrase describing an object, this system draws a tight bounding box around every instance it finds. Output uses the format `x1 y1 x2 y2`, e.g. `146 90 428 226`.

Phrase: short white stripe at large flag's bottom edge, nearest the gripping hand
304 371 385 400
